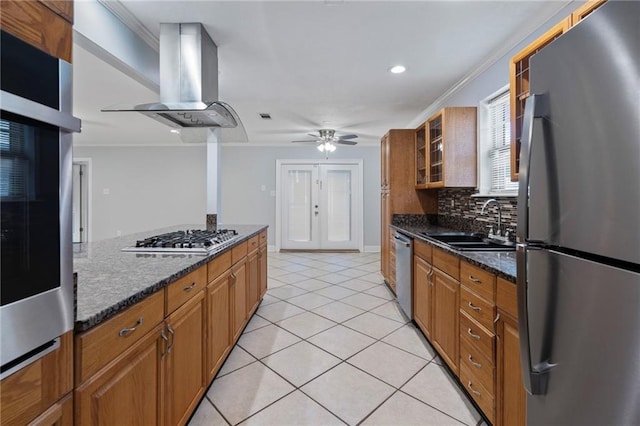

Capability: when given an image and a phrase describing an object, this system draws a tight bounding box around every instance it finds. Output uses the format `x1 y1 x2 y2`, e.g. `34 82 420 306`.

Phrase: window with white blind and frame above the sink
478 87 518 195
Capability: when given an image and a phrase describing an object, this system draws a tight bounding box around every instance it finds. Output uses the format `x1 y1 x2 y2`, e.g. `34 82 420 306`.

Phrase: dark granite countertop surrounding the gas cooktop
73 224 267 331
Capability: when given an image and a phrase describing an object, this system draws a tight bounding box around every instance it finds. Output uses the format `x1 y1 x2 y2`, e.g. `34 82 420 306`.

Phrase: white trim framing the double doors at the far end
275 158 364 253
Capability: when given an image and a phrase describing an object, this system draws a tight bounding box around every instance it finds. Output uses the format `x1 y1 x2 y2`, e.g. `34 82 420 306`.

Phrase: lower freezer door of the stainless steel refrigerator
518 248 640 426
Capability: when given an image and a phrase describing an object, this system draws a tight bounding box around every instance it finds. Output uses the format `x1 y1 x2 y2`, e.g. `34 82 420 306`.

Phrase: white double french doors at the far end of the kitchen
278 161 362 250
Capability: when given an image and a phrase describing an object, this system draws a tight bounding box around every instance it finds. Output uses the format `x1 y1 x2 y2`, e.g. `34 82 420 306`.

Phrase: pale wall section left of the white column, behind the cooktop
73 144 207 241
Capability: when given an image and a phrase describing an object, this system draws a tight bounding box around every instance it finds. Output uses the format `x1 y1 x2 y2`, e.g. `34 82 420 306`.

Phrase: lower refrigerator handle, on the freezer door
516 244 555 395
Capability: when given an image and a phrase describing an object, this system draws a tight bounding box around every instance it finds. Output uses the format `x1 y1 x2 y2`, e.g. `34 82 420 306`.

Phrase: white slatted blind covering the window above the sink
488 91 518 193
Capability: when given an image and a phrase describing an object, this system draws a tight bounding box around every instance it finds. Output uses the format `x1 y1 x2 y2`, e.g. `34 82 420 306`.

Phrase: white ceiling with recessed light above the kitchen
73 0 568 149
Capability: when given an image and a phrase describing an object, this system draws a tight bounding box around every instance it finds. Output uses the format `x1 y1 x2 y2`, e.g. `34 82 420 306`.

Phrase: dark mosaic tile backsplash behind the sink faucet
438 188 518 236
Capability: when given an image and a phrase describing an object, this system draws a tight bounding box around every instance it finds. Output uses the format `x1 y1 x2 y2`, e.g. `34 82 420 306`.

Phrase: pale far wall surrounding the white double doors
218 145 380 246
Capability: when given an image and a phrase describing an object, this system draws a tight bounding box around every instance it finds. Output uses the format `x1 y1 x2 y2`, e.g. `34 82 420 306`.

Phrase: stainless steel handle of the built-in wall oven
0 90 81 132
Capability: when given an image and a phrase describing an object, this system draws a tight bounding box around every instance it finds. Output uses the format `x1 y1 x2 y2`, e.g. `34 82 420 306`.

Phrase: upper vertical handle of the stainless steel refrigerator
517 95 547 242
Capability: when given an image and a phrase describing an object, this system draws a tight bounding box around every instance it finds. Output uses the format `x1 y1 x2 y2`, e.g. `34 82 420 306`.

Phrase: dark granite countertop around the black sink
391 223 516 283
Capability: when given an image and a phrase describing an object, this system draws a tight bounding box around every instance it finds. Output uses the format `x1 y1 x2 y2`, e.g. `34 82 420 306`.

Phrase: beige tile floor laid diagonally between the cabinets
189 253 484 426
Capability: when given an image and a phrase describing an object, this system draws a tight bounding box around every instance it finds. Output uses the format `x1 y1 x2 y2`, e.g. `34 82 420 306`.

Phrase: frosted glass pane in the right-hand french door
326 170 351 241
